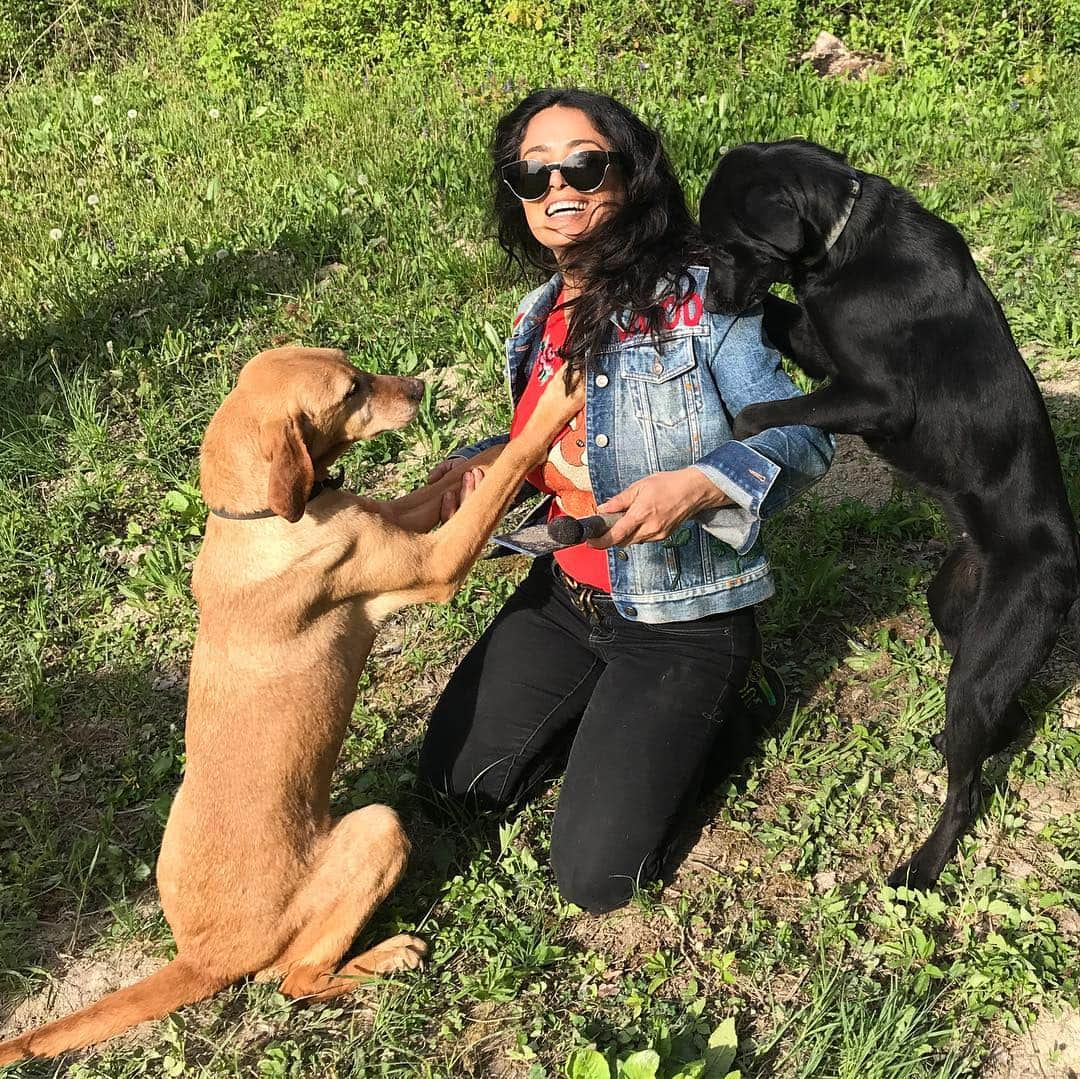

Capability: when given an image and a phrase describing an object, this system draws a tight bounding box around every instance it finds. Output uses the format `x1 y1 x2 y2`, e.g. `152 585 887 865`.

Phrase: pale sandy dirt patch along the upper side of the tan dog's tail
0 945 164 1038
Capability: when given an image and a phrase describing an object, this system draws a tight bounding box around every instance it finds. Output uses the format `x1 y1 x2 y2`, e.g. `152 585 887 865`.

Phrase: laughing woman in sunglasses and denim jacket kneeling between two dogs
420 90 833 912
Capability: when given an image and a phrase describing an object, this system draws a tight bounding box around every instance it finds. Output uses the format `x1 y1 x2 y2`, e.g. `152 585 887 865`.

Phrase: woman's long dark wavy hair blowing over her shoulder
491 89 707 377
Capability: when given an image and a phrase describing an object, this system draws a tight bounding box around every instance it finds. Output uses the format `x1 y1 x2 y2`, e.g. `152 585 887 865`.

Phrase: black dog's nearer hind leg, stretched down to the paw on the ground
889 570 1068 888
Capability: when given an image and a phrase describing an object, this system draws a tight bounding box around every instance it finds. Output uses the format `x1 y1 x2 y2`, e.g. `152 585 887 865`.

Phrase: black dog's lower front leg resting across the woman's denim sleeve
733 379 910 439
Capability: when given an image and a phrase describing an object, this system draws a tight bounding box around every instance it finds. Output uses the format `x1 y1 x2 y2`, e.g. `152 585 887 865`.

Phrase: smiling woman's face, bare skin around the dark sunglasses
521 105 626 260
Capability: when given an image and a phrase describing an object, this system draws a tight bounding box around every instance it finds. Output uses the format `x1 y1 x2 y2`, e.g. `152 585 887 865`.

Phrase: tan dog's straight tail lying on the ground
0 956 233 1066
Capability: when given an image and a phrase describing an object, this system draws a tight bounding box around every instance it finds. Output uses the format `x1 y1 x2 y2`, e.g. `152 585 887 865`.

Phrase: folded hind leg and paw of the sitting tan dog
265 806 426 999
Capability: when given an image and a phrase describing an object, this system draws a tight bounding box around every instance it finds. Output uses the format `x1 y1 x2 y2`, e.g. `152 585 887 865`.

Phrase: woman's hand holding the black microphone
589 468 731 549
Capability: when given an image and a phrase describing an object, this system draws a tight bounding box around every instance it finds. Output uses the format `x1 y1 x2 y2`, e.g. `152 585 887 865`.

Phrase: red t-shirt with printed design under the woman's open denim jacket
510 293 611 592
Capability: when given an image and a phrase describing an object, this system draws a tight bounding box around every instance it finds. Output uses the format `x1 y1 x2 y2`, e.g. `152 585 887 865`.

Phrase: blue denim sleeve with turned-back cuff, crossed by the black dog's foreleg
694 307 836 554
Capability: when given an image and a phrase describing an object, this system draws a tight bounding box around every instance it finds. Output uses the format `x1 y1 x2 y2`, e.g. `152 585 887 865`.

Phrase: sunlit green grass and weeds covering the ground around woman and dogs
0 3 1080 1079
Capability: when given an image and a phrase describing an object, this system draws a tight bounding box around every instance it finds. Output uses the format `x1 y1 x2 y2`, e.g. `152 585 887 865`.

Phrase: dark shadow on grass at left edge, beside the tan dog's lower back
0 664 184 1014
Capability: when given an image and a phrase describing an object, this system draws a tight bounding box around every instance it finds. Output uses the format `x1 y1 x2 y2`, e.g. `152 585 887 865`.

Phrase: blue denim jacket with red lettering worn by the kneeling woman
453 267 835 622
